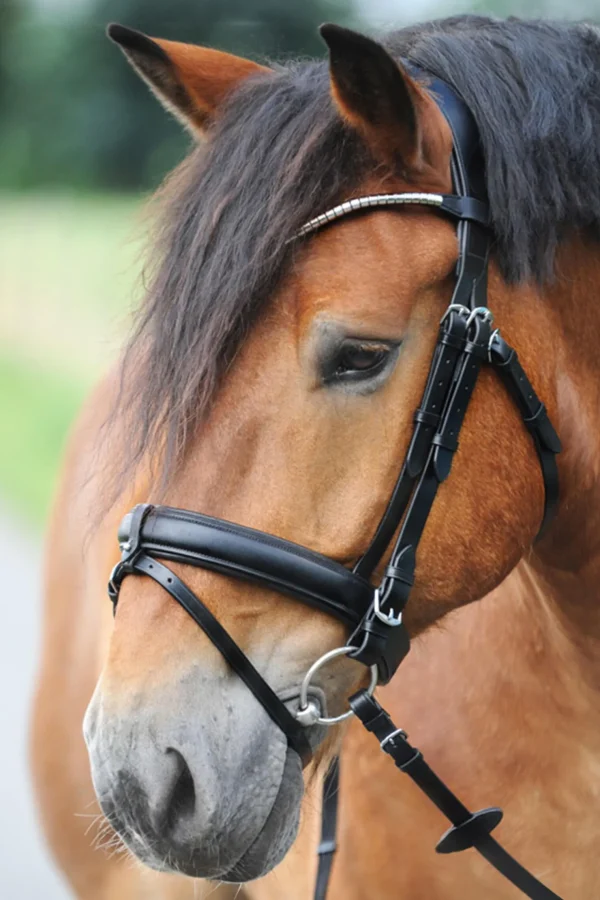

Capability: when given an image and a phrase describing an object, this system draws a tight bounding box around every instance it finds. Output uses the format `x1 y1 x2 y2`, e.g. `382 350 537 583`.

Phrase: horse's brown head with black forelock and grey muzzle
85 26 557 881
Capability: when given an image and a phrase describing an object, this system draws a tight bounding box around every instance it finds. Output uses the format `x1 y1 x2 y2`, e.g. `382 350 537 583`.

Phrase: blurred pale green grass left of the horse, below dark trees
0 195 142 525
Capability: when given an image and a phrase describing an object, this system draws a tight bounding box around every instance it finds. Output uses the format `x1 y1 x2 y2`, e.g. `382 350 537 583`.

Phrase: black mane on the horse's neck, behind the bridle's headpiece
383 16 600 282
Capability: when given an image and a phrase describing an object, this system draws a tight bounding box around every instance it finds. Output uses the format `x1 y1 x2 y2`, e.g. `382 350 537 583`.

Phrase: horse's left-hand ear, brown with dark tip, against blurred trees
106 23 271 134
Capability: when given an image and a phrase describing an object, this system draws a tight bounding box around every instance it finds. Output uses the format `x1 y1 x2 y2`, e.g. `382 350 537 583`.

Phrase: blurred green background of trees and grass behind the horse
0 0 600 525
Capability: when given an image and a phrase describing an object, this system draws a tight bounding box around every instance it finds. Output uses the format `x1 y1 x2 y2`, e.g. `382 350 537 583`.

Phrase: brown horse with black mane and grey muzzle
31 16 600 900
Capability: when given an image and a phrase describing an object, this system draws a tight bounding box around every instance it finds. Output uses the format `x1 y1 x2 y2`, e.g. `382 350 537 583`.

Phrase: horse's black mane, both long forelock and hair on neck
120 16 600 486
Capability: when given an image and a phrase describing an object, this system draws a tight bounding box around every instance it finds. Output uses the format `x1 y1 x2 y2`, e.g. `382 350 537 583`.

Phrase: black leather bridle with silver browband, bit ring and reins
109 65 561 900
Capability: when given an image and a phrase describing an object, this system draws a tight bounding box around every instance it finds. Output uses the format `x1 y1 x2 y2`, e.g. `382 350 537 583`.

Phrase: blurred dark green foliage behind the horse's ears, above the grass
0 0 352 190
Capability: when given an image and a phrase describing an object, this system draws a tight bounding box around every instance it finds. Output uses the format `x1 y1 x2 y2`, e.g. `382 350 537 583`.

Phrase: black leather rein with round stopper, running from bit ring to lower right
350 691 560 900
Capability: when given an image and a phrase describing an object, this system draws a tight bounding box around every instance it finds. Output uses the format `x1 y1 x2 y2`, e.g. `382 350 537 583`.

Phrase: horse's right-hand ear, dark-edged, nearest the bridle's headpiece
320 24 422 171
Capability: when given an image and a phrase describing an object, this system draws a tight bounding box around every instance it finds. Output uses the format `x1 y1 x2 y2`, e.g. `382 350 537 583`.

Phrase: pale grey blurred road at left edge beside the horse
0 508 71 900
